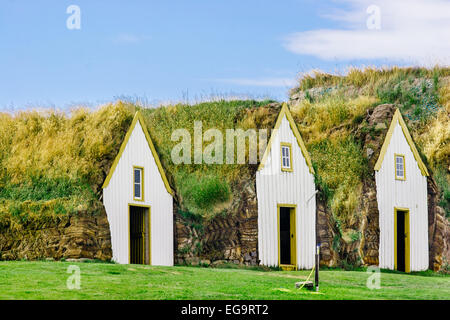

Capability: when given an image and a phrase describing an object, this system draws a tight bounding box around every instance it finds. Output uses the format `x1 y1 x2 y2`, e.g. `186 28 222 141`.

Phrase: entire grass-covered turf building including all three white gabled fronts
0 68 450 271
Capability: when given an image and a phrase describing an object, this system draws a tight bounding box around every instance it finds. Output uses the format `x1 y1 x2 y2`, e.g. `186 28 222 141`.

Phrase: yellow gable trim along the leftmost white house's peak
102 111 173 196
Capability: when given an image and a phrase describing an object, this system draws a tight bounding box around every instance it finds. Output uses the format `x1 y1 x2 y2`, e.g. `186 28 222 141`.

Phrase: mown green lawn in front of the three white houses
0 261 450 299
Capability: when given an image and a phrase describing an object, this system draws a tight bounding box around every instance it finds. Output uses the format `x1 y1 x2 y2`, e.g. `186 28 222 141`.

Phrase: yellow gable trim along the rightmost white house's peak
374 109 429 177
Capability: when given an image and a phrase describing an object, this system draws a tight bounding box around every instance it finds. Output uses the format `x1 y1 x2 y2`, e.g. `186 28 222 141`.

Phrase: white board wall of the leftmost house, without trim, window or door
103 121 173 266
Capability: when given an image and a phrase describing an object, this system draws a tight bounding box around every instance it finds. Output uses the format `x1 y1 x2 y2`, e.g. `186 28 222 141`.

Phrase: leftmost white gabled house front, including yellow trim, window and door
103 112 173 266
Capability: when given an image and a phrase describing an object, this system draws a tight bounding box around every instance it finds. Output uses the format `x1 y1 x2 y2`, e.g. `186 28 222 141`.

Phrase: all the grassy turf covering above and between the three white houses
0 68 450 237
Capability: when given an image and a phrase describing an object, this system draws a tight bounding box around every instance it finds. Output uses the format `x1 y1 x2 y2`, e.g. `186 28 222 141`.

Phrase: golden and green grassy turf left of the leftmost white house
0 103 134 228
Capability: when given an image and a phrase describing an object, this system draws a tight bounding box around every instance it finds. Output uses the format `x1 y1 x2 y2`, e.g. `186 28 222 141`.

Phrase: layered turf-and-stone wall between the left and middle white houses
174 179 258 265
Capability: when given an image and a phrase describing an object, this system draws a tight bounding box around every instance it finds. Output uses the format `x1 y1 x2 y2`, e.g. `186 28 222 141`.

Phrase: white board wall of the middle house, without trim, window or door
256 116 316 269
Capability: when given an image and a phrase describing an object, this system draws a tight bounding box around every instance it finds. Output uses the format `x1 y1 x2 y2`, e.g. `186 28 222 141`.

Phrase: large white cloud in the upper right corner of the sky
284 0 450 65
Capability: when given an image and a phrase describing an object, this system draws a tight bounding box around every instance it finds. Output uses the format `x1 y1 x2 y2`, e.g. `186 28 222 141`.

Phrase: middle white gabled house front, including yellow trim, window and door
256 104 316 269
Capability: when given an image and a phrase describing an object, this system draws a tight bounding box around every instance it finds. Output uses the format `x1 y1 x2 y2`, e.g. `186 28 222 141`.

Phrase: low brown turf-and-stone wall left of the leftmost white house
0 210 112 260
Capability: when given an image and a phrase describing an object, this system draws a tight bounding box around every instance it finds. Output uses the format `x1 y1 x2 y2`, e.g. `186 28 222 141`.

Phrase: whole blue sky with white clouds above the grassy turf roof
0 0 450 110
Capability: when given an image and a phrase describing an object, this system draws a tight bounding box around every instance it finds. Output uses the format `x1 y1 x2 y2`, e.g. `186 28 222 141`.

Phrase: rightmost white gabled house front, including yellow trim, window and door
375 109 429 272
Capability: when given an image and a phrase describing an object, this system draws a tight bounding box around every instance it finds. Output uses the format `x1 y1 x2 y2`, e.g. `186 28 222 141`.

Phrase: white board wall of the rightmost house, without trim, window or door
375 122 428 271
